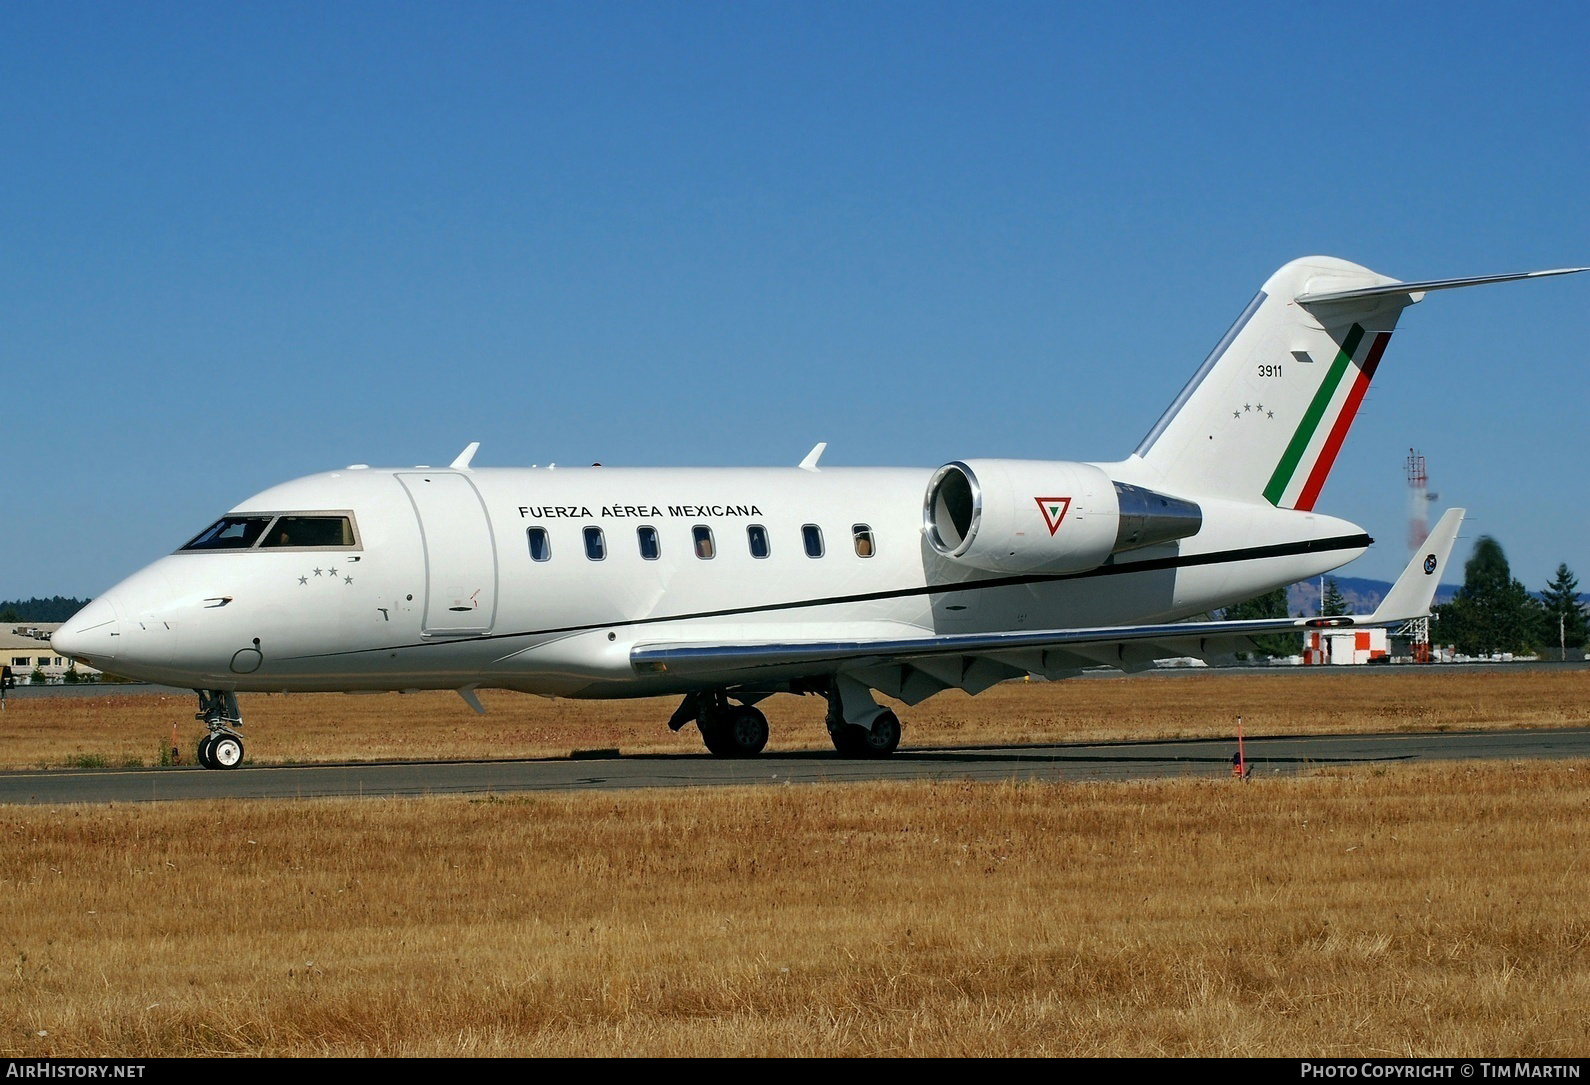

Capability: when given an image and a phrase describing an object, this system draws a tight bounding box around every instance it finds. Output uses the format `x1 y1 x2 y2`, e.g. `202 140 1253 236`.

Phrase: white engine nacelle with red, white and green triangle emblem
922 460 1204 573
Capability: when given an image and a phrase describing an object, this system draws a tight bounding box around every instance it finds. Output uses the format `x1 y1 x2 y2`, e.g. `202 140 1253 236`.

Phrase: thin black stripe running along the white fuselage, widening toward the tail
285 535 1374 660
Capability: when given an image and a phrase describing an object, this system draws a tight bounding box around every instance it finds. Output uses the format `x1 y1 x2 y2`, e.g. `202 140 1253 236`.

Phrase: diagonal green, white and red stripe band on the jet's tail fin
1264 325 1391 511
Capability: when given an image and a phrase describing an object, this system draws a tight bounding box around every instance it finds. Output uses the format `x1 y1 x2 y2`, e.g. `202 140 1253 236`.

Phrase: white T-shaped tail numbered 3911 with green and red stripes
1132 256 1590 511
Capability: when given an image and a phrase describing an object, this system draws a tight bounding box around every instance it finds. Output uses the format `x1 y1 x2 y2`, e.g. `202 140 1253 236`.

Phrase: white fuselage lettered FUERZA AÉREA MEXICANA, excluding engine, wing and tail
56 461 1369 697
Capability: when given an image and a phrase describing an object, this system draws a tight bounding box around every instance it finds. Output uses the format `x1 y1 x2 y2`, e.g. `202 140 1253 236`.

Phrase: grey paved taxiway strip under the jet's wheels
0 727 1590 803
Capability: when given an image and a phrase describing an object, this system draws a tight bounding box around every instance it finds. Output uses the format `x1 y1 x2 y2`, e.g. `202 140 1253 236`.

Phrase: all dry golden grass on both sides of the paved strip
0 671 1590 1058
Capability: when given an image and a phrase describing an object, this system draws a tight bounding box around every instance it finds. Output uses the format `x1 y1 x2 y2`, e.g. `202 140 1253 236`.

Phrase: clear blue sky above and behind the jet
0 2 1590 598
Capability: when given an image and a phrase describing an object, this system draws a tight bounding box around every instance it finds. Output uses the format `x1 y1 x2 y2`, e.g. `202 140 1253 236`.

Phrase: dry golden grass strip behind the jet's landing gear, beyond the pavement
0 667 1590 768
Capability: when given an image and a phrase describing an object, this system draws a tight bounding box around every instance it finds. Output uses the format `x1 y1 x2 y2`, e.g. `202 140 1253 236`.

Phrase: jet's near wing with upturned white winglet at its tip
630 509 1464 693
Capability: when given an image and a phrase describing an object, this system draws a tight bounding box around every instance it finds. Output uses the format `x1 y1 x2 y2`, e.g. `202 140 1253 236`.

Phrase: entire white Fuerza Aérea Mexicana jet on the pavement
52 256 1585 768
